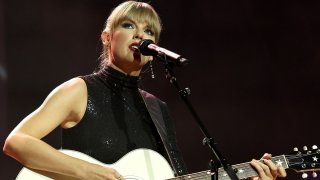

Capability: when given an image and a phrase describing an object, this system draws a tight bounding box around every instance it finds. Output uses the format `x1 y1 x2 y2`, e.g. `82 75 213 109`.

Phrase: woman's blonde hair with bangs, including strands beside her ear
100 1 162 67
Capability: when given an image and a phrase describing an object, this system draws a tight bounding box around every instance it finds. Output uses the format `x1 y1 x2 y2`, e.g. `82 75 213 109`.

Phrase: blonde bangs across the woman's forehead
109 2 161 43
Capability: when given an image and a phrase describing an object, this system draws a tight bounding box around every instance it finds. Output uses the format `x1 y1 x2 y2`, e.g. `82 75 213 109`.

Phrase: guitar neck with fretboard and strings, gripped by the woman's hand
170 155 288 180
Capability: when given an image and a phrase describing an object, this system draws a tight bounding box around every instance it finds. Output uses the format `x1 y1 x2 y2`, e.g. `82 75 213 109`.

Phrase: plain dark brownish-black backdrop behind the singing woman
0 0 320 179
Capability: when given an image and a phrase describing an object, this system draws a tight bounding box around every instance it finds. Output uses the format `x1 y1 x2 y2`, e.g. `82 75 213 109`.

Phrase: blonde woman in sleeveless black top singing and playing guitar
4 1 279 180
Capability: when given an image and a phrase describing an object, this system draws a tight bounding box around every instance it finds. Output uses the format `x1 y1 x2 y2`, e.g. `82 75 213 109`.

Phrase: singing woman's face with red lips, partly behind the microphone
104 19 155 73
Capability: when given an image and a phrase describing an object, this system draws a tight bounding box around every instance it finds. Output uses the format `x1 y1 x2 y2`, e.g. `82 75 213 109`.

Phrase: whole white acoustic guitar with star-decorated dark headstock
16 145 320 180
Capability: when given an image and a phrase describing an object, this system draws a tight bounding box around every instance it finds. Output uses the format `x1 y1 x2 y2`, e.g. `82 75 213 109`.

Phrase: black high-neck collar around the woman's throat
98 66 140 88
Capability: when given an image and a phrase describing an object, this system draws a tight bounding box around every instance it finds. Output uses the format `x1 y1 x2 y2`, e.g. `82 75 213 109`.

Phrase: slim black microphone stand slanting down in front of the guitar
155 54 239 180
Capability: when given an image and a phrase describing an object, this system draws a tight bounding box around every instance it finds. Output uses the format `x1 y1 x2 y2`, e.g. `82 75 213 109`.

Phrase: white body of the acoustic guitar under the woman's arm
16 149 174 180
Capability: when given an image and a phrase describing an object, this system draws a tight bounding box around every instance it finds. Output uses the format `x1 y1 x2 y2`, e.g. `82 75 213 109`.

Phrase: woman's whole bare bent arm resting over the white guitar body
3 78 119 179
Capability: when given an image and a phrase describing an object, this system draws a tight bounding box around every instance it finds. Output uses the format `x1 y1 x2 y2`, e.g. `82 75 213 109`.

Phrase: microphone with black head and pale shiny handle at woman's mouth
138 39 189 67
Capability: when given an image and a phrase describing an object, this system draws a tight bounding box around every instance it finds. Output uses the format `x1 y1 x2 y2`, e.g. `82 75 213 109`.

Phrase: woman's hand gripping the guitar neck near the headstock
250 153 287 180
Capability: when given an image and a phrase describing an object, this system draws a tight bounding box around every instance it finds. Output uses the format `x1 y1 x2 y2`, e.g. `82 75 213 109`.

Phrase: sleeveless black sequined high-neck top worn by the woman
62 67 186 175
